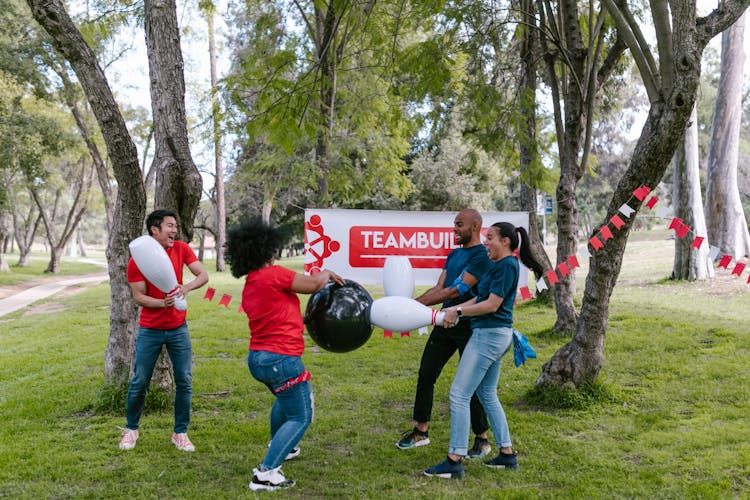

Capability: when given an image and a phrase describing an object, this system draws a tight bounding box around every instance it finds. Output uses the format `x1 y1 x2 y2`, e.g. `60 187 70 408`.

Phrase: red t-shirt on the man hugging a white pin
128 240 198 330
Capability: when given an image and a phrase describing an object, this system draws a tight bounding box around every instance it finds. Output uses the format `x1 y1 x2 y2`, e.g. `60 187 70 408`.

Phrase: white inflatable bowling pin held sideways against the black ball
370 295 445 332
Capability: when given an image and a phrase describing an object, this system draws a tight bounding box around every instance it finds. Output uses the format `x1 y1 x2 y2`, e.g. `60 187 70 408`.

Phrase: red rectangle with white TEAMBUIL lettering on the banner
349 226 456 269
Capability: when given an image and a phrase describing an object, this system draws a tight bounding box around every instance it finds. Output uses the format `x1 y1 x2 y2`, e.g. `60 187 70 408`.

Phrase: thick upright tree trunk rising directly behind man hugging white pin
144 0 203 242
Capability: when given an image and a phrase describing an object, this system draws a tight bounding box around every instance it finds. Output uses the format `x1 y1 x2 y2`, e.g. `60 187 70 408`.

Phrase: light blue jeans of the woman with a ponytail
448 328 513 456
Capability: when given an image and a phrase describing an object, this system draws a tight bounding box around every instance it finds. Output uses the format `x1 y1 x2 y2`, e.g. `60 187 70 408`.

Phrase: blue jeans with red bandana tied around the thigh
247 351 313 470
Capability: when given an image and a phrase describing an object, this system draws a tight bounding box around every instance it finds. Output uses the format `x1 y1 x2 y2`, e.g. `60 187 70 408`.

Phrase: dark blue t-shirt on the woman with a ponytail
471 255 519 328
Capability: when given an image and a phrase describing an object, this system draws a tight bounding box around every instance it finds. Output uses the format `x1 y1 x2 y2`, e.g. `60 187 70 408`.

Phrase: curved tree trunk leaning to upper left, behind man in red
27 0 146 385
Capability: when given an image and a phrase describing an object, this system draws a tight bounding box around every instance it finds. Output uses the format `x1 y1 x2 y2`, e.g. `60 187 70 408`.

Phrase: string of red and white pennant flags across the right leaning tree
519 185 750 300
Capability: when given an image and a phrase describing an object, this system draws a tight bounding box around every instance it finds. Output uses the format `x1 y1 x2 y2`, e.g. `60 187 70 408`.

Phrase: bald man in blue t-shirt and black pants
396 208 491 458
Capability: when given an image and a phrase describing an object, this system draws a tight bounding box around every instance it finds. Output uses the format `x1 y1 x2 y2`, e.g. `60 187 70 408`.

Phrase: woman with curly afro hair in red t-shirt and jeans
226 220 344 491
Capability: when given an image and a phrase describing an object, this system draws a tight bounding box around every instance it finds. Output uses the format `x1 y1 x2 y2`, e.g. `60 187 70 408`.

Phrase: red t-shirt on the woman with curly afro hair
242 266 305 356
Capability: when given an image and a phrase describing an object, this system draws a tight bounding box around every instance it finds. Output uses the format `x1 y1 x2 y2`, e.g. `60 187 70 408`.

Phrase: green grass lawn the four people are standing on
0 239 750 499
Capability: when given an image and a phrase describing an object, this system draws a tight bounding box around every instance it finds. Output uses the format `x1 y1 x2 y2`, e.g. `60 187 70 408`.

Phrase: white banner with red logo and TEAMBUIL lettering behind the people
305 208 529 287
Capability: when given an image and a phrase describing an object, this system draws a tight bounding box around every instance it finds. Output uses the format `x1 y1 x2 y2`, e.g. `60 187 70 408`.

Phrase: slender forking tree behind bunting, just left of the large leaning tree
539 0 626 333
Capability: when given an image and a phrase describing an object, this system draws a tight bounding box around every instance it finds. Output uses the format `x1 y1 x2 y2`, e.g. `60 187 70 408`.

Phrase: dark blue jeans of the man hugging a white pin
126 323 193 433
